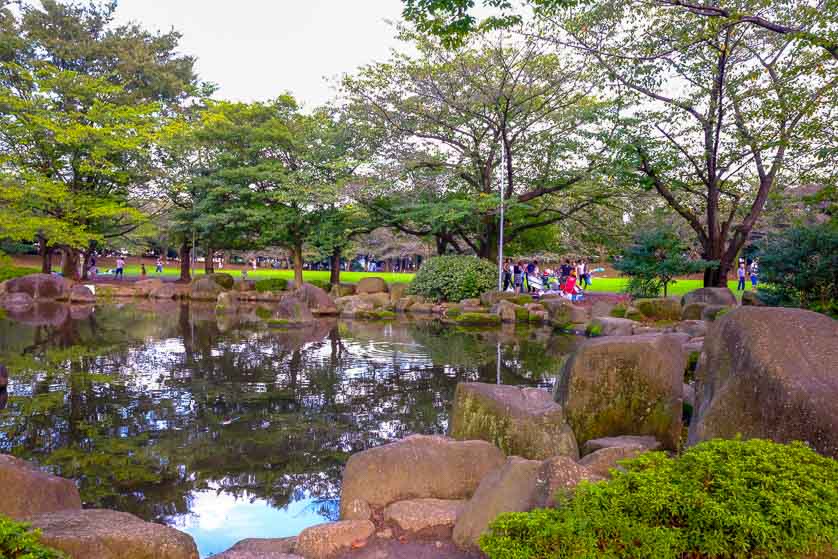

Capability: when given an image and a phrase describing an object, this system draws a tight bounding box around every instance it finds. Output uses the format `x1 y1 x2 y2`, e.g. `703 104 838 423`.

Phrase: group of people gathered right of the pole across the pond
503 258 591 299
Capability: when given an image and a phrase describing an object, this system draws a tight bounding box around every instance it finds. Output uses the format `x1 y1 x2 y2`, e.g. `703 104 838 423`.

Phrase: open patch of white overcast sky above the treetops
116 0 402 108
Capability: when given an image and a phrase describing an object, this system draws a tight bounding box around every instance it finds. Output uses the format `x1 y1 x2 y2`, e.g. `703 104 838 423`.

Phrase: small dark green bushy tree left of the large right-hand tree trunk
614 228 718 297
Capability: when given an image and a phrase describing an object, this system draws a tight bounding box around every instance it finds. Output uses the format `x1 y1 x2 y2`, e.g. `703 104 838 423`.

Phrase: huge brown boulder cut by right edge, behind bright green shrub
689 307 838 458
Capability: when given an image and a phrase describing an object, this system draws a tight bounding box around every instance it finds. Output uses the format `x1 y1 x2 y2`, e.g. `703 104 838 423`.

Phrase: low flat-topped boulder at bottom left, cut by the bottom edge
28 509 198 559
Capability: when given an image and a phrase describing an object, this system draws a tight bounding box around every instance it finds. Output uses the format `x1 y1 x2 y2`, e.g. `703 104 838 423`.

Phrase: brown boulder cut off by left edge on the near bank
0 454 81 520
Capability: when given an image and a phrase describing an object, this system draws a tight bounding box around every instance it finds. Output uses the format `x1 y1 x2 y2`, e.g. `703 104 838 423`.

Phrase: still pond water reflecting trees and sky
0 302 577 557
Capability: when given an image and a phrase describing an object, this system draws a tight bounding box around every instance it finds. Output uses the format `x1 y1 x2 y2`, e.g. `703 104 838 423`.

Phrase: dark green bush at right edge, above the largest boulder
758 223 838 317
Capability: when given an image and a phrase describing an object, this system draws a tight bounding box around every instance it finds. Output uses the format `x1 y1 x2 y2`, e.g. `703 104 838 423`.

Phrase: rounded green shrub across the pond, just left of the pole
408 256 498 302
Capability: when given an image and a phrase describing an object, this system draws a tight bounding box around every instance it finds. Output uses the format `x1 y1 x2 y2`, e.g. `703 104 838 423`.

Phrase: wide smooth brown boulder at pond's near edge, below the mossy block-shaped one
341 435 504 518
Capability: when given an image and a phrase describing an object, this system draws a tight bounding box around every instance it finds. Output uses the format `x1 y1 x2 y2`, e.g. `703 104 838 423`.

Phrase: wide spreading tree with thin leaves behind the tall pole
344 31 610 260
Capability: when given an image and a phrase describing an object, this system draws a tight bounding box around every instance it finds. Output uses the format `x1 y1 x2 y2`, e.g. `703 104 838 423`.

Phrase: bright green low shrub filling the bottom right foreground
480 439 838 559
